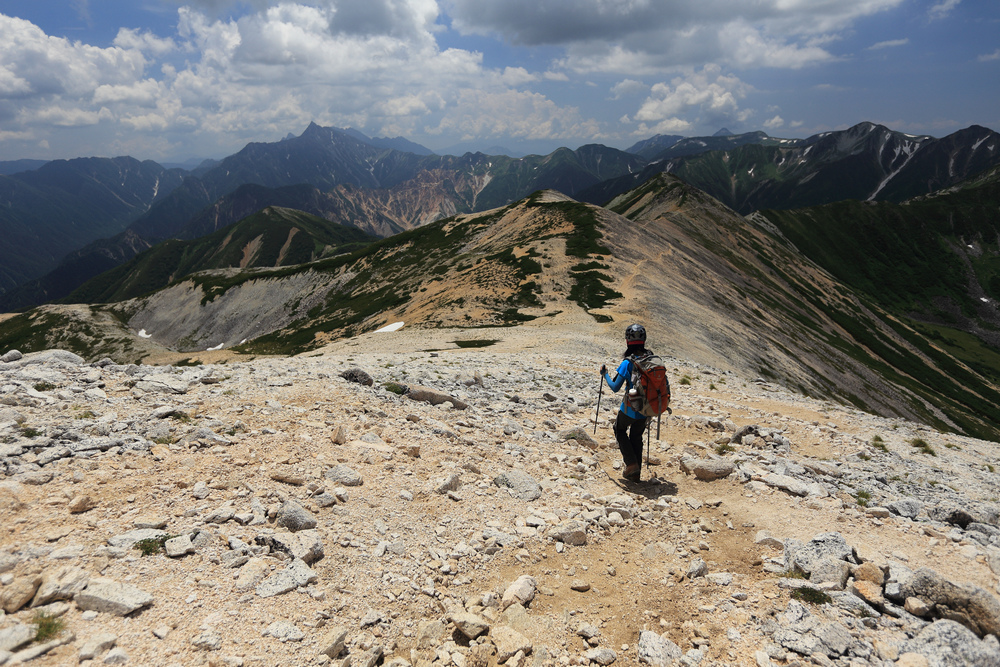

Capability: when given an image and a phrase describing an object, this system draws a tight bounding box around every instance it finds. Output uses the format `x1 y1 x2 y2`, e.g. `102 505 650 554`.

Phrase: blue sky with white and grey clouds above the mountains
0 0 1000 161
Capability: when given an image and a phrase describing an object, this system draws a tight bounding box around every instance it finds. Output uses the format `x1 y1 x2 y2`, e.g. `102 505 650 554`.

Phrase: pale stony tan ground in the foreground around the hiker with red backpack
0 327 1000 667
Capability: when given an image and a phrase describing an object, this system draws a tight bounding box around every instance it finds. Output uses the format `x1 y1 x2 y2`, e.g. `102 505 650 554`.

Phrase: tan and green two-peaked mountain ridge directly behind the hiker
0 174 1000 439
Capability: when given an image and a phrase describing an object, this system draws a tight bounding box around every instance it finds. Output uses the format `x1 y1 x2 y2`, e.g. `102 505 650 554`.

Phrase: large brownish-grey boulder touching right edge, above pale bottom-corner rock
900 567 1000 637
